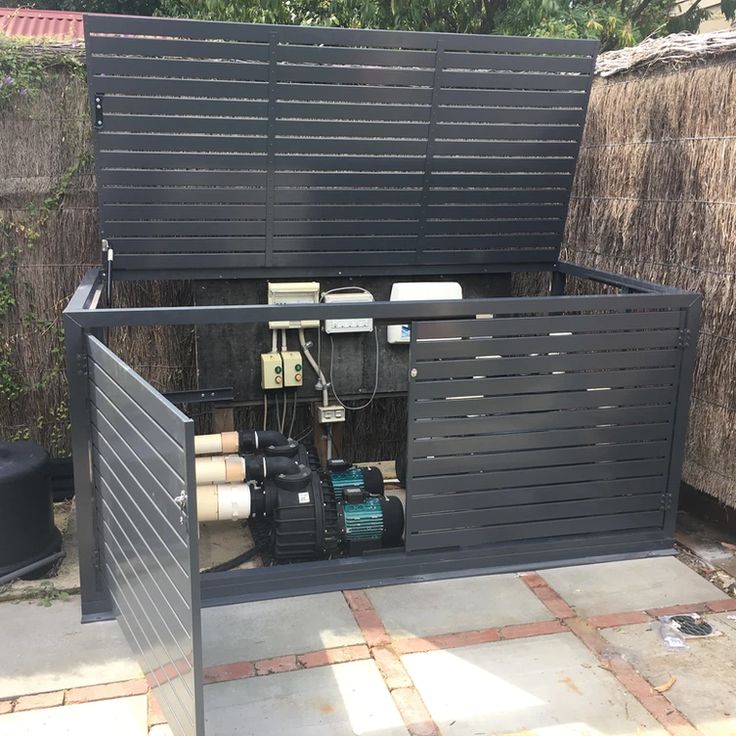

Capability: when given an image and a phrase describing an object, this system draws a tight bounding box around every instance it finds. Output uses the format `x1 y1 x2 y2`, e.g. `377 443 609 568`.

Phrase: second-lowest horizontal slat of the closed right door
413 493 662 534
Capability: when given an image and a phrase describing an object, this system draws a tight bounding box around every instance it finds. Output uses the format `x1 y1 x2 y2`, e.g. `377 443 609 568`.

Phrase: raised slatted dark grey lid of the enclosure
85 15 597 279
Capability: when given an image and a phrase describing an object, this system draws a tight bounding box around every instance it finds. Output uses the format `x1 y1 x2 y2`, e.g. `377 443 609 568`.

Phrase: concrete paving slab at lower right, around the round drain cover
603 614 736 736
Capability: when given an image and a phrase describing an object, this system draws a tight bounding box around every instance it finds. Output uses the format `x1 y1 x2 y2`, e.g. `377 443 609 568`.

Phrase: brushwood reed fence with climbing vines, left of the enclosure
0 46 194 456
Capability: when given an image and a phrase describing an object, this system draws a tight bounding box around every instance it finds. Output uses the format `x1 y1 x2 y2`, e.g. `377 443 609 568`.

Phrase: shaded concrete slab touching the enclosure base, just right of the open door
202 593 363 666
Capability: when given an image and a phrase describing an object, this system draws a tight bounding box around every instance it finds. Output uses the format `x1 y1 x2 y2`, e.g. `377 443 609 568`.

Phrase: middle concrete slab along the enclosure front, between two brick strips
367 575 552 637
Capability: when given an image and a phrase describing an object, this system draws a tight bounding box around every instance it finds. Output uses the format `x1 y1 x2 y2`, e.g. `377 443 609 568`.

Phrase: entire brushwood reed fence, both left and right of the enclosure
0 36 736 506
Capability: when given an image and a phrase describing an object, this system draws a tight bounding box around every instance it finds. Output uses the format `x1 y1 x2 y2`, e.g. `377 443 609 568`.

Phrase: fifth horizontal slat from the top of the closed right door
414 388 674 419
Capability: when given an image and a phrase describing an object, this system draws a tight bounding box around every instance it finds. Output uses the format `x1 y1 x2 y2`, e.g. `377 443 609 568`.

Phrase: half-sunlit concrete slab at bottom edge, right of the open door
205 660 407 736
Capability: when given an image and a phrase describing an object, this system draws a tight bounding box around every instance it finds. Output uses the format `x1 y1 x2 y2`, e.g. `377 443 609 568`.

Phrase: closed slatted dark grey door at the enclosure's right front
407 304 685 551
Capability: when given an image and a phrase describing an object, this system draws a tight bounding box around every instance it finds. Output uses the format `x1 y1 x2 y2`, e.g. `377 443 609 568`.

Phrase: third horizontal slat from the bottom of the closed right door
412 475 665 515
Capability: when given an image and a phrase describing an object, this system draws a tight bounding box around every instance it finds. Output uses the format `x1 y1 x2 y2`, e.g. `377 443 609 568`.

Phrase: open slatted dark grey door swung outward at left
88 337 204 736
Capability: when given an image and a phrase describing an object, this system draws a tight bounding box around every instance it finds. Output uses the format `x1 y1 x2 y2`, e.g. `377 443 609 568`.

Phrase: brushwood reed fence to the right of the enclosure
563 32 736 506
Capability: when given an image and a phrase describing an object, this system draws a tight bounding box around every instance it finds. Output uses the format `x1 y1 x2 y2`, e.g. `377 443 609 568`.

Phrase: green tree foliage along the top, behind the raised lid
10 0 736 50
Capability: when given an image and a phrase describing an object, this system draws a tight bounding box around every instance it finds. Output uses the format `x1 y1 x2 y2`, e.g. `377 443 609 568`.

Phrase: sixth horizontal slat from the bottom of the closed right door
412 417 671 459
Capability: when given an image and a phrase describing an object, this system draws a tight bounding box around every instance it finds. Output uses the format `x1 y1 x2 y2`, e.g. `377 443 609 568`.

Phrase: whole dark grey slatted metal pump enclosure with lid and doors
64 11 700 736
